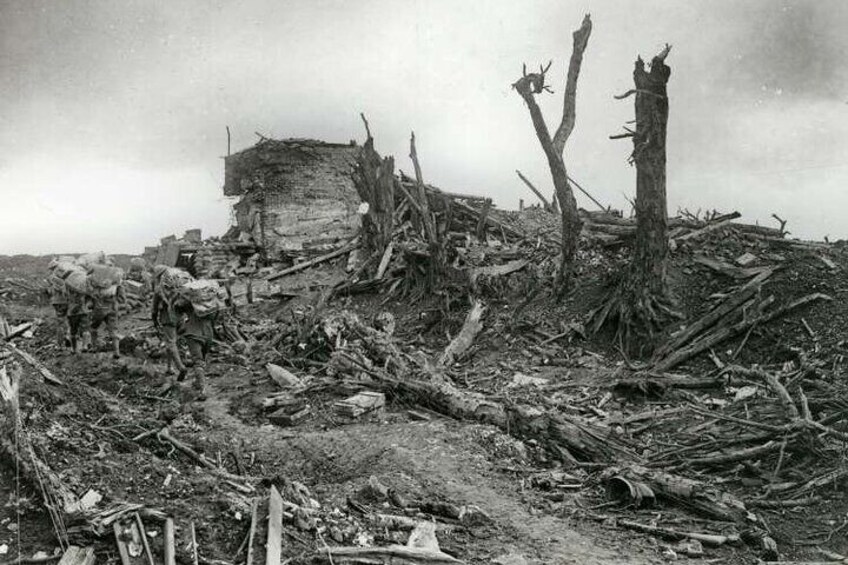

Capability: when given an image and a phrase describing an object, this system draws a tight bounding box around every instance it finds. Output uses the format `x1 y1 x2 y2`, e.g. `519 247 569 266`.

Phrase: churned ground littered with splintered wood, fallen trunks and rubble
0 202 848 565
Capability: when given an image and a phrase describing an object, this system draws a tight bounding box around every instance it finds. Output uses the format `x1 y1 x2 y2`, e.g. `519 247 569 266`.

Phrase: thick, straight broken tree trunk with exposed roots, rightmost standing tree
594 45 677 353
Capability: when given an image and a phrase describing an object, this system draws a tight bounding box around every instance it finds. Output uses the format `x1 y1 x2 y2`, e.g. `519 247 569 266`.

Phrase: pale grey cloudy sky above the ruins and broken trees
0 0 848 253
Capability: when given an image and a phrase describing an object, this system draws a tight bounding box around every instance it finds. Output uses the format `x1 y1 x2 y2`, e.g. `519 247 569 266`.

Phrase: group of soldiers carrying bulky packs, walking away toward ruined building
48 254 231 395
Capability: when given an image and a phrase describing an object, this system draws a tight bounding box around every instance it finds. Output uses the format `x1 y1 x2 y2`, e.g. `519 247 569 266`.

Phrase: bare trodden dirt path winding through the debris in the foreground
189 368 658 565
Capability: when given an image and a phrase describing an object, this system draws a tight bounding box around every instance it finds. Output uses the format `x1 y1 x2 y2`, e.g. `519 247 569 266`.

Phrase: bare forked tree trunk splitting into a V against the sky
512 14 592 295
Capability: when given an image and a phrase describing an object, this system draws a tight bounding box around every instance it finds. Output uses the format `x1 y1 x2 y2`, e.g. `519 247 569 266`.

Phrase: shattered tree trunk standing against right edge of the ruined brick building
353 115 395 274
